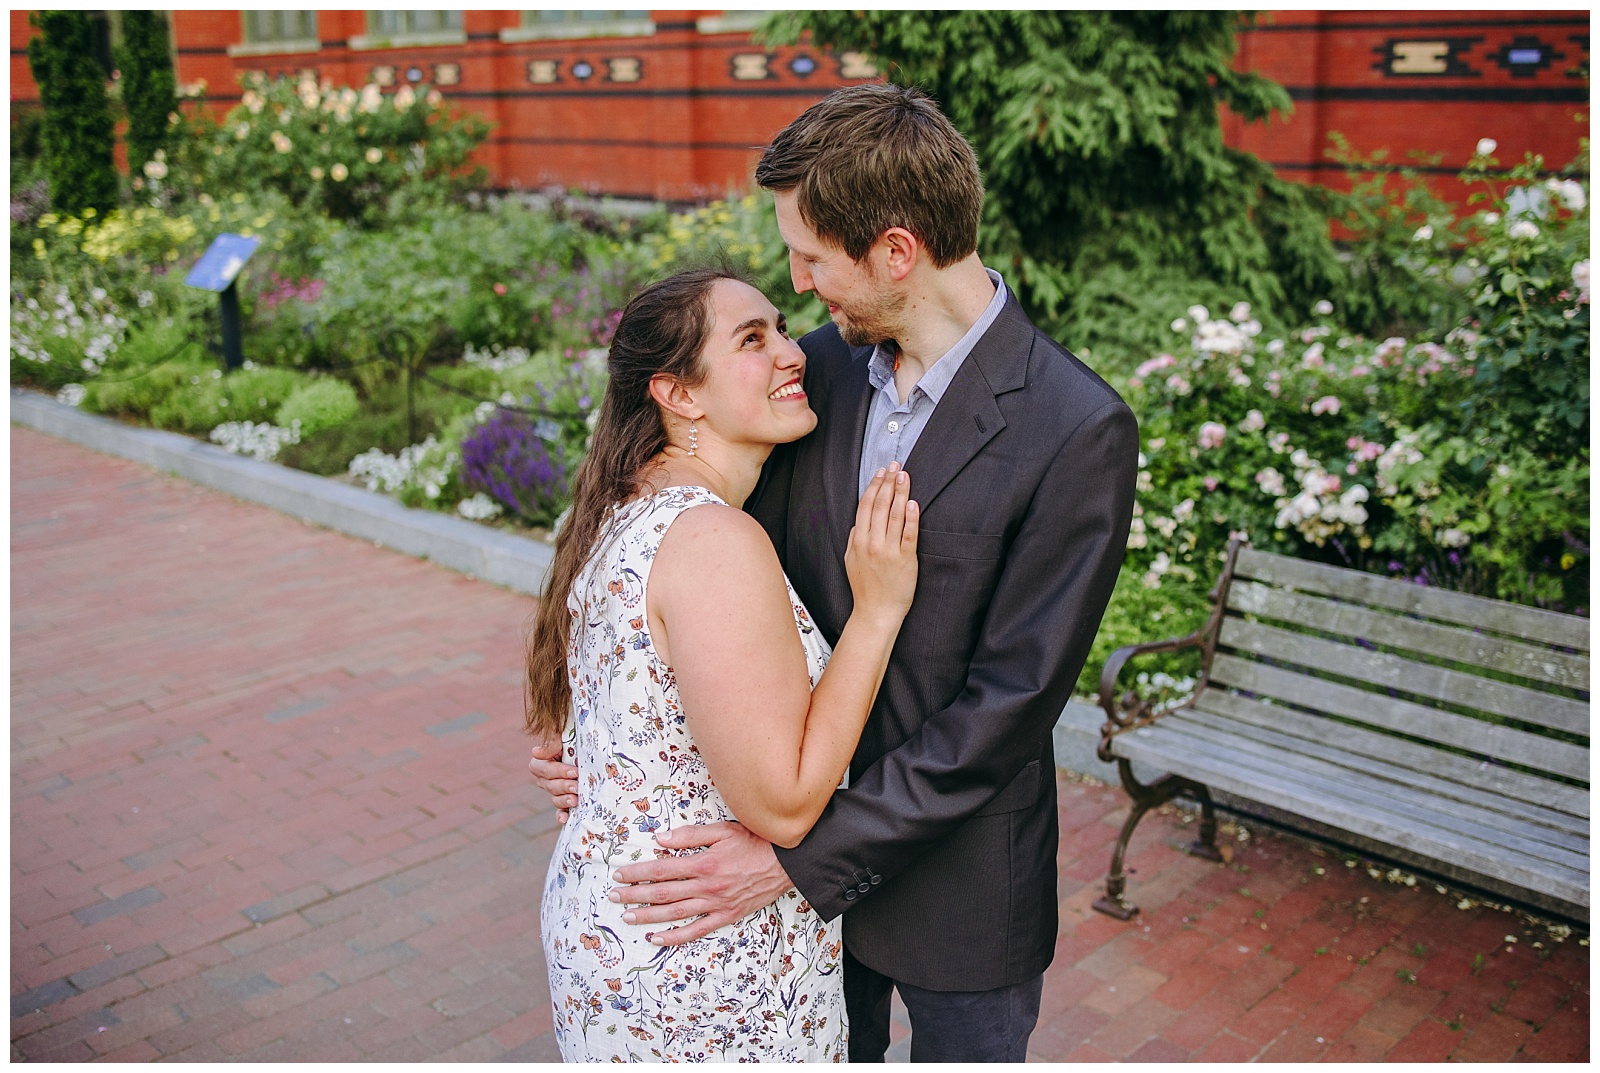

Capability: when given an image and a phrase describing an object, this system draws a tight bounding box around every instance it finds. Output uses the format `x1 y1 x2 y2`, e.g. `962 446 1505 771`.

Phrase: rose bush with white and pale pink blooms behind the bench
1091 148 1589 697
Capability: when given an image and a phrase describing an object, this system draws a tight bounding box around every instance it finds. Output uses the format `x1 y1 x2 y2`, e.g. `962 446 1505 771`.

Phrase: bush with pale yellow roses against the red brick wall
198 75 488 225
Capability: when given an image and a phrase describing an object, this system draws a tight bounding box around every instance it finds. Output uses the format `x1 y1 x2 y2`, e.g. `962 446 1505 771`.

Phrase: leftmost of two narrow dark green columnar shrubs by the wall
27 11 117 213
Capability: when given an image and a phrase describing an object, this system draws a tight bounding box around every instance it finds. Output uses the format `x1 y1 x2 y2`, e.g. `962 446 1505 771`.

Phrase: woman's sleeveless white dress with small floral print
542 488 846 1062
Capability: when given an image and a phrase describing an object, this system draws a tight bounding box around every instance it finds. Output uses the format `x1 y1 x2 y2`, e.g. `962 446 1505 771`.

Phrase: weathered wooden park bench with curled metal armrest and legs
1094 540 1589 923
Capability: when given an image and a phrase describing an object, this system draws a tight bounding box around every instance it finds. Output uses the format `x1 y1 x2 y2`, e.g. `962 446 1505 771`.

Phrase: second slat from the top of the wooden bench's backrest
1227 580 1589 689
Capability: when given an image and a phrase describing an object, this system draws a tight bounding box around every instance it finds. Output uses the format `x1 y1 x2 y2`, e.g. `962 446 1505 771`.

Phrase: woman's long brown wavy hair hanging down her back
526 267 744 740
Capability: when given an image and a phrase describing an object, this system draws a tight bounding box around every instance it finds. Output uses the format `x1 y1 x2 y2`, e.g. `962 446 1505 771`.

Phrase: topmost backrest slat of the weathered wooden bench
1234 548 1589 652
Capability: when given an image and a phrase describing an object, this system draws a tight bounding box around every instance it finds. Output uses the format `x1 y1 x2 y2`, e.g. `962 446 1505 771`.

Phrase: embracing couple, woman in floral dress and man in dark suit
528 85 1138 1062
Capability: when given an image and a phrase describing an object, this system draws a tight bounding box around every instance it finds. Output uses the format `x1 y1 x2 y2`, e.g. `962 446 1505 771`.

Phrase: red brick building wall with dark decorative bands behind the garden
11 11 1589 201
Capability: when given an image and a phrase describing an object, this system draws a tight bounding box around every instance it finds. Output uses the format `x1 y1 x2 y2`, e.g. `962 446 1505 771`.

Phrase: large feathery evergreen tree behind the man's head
765 10 1347 350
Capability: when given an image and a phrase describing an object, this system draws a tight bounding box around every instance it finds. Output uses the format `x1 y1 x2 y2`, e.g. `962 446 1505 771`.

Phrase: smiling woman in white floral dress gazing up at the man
528 263 918 1062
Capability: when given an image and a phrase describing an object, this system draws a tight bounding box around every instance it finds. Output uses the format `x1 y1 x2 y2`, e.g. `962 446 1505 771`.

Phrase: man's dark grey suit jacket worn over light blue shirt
746 297 1139 991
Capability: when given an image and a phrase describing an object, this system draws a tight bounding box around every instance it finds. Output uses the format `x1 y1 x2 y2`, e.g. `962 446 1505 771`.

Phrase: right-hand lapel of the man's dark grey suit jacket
902 296 1034 512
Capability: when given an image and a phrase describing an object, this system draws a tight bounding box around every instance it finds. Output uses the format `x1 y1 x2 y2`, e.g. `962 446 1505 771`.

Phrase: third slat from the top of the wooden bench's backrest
1219 617 1589 738
